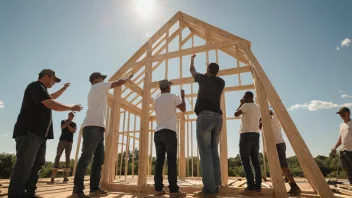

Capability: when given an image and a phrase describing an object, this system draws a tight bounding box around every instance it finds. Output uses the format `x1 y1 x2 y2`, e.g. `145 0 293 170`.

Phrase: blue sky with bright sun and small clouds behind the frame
0 0 352 160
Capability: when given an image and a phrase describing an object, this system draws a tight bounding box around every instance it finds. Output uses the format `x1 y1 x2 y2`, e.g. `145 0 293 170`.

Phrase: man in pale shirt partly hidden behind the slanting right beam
259 110 301 196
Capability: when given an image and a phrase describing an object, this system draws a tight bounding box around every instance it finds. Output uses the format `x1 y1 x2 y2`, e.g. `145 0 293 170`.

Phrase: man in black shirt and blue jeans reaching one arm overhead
190 55 225 197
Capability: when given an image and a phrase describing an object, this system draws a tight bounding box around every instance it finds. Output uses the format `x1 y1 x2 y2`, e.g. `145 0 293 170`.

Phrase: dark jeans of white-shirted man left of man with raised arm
154 129 179 193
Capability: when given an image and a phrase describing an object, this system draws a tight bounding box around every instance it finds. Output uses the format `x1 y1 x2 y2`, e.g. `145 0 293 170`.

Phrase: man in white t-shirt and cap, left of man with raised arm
154 79 186 197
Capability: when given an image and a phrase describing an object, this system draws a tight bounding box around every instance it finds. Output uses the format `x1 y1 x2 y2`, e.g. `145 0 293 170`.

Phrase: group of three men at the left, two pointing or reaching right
8 69 133 198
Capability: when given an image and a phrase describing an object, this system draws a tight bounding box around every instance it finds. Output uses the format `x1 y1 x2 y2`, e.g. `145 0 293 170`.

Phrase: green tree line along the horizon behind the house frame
0 149 347 179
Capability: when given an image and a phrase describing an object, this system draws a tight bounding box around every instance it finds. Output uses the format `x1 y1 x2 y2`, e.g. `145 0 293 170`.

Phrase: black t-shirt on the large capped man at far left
13 81 54 139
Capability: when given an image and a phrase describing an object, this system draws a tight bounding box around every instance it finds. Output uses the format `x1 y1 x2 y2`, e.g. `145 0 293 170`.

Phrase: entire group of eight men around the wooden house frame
8 55 352 198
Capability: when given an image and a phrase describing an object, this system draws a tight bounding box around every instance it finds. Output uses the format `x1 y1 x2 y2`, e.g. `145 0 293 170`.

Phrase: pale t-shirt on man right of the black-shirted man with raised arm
240 102 260 133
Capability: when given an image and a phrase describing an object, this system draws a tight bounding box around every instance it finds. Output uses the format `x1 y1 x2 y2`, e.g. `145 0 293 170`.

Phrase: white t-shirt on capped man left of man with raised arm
154 93 182 132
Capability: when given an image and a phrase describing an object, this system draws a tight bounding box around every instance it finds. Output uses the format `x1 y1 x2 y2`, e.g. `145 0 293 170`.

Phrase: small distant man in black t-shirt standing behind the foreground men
51 112 76 182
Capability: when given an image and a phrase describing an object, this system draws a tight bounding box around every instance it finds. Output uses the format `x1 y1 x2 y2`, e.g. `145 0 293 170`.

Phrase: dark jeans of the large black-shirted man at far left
8 134 47 197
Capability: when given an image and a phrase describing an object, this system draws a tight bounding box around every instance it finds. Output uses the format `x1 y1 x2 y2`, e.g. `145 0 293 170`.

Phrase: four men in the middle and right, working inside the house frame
154 55 301 197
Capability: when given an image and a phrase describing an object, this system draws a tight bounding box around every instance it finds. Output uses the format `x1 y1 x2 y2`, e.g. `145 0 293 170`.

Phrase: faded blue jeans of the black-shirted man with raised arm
197 111 223 194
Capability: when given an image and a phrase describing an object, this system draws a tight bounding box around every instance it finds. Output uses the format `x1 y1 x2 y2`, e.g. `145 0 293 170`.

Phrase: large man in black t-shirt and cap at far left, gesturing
8 69 82 197
